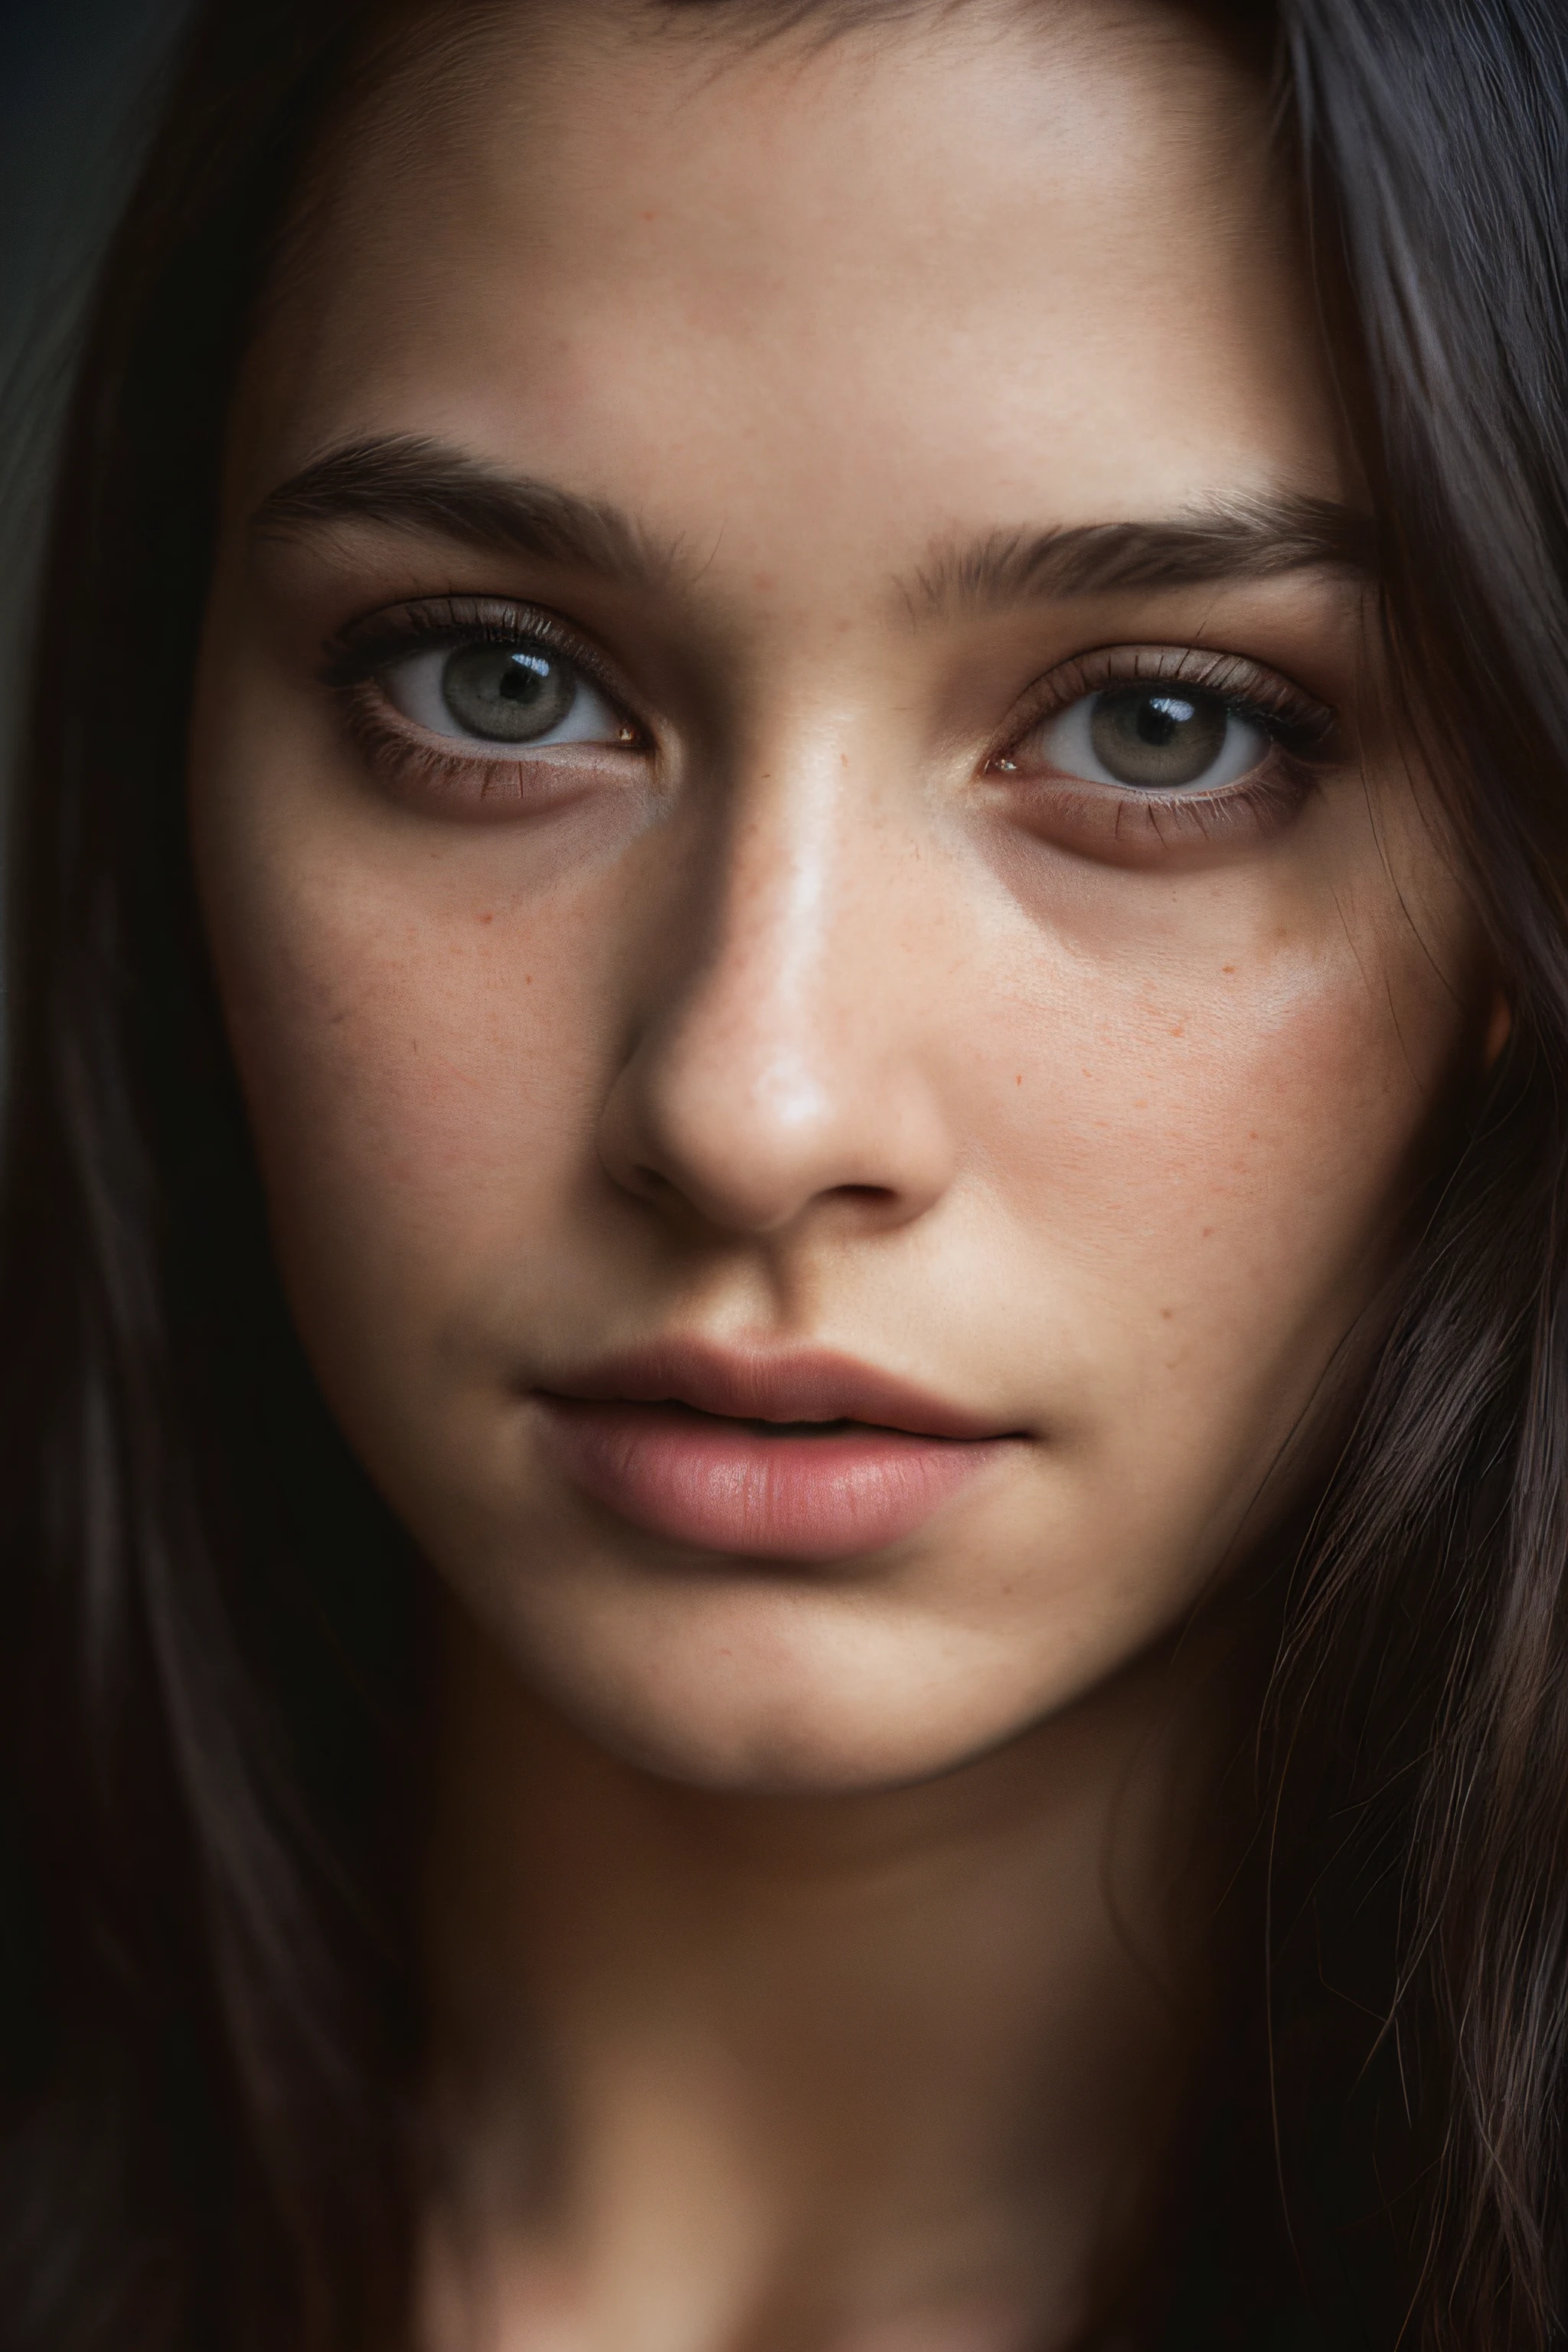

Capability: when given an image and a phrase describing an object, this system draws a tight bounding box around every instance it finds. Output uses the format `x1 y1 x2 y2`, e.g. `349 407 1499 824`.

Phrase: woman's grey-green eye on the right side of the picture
1029 678 1272 792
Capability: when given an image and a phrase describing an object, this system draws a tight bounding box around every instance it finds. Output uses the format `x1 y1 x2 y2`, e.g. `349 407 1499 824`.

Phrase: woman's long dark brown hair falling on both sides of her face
0 0 1568 2352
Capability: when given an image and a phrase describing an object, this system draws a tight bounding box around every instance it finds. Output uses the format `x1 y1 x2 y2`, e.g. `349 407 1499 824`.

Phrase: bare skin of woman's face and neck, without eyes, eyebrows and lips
193 0 1500 2352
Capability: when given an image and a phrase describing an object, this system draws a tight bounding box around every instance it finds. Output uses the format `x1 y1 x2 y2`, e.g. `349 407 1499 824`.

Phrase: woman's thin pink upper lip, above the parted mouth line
541 1341 1021 1439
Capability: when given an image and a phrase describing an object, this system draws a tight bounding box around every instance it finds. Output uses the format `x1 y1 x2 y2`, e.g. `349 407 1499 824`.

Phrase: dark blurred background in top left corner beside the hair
0 0 190 779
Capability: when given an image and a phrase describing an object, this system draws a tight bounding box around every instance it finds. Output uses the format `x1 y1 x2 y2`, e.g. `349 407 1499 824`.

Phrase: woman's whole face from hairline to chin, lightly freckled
193 0 1491 1790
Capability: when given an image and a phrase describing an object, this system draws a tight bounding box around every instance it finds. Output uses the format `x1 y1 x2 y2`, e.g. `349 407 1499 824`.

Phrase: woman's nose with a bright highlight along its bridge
599 753 955 1237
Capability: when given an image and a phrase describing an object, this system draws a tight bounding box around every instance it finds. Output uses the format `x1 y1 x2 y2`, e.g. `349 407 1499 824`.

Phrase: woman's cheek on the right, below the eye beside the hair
988 887 1481 1512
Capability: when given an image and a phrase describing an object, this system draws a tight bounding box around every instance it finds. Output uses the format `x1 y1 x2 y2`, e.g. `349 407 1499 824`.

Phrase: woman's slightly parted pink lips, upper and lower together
536 1343 1021 1560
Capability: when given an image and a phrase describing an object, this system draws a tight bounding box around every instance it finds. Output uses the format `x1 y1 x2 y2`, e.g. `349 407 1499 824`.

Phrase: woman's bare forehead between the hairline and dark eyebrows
235 0 1338 547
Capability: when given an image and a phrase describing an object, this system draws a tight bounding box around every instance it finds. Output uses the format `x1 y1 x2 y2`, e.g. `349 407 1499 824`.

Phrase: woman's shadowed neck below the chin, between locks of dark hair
413 1623 1234 2352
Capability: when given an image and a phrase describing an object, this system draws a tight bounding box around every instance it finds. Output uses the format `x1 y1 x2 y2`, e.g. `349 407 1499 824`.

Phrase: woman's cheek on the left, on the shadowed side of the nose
198 771 616 1393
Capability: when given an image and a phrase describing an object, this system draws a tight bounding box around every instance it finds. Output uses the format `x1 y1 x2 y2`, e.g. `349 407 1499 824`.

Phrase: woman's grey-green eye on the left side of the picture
381 638 632 750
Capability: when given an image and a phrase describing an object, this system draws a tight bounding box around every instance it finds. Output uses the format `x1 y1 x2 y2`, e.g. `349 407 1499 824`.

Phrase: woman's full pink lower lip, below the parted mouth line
538 1397 1006 1560
